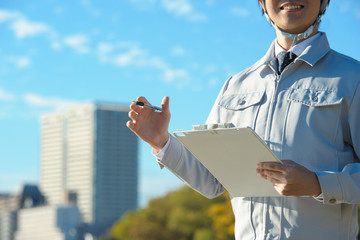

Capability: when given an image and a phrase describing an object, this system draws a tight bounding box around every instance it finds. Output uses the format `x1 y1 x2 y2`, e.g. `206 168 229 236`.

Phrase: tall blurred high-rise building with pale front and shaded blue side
40 103 138 234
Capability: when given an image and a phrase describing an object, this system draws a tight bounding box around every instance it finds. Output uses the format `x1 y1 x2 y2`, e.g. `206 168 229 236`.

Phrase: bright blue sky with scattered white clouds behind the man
0 0 360 206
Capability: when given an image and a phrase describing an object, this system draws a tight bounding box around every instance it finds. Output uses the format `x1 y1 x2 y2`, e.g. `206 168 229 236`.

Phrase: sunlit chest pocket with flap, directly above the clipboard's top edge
219 91 265 128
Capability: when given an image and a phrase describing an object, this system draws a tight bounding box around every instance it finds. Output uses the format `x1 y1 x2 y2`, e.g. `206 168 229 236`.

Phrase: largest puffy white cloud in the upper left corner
11 18 50 38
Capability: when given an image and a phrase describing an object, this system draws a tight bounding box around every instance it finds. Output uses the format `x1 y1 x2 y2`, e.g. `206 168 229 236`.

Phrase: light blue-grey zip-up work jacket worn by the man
158 33 360 240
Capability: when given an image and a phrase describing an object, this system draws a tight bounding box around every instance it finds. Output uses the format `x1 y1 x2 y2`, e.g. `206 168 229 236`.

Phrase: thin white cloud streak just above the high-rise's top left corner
24 93 78 111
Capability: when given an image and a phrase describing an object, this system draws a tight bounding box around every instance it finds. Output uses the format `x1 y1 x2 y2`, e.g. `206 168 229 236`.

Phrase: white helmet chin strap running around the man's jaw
262 0 330 45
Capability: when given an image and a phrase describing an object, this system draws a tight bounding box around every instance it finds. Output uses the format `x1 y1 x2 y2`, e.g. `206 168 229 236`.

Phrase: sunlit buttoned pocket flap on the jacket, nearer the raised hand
219 91 264 110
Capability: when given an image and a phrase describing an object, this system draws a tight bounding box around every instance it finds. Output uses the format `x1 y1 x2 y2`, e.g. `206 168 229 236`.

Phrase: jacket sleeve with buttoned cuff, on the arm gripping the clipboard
316 80 360 204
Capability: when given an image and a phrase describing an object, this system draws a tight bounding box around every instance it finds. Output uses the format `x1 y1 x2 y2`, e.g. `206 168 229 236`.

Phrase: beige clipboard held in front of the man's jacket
173 127 280 197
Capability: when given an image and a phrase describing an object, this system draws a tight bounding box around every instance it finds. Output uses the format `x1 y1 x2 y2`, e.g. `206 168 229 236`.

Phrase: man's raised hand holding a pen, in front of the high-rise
126 96 171 152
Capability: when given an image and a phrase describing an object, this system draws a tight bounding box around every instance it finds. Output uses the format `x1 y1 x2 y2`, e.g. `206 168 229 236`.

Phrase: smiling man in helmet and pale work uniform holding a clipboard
127 0 360 240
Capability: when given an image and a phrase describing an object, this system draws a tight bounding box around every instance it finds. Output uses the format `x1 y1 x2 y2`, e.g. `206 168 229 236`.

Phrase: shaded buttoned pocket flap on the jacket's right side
288 89 343 107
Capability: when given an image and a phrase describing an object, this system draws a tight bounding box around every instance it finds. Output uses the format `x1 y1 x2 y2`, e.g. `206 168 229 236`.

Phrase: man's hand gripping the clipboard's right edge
256 160 321 197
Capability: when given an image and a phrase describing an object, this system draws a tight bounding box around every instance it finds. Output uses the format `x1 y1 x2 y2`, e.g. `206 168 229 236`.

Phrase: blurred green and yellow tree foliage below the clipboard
103 187 234 240
